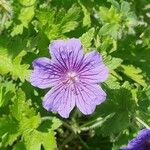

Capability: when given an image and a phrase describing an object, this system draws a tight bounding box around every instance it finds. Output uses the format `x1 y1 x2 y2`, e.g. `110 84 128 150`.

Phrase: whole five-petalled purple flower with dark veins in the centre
30 38 108 118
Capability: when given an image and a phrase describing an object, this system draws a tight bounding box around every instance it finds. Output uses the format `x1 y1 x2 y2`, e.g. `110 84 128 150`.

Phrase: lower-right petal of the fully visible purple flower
76 83 106 115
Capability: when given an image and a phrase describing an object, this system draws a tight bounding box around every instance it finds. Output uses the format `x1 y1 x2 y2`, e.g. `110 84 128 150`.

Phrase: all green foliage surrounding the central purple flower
0 0 150 150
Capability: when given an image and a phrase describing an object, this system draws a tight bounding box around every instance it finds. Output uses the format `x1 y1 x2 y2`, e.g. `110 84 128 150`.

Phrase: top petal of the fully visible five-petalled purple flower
49 38 83 70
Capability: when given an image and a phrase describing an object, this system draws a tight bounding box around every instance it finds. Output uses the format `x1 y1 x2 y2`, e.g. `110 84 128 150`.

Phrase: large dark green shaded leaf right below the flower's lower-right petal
95 88 135 135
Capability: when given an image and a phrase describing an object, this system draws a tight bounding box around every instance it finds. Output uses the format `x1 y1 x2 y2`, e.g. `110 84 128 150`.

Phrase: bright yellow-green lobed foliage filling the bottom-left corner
0 89 60 150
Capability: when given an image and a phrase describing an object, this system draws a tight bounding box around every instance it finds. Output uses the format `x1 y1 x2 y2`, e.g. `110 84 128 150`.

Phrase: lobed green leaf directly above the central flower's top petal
37 5 81 40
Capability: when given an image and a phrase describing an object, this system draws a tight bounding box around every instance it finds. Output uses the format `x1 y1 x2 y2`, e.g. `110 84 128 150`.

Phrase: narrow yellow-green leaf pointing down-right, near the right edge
121 65 147 87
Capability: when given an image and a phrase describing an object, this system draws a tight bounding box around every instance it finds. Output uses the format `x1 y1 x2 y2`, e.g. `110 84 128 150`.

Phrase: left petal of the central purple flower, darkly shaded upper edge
30 57 62 89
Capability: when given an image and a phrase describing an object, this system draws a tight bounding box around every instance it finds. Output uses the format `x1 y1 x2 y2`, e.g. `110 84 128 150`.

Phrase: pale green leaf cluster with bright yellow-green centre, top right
99 1 137 39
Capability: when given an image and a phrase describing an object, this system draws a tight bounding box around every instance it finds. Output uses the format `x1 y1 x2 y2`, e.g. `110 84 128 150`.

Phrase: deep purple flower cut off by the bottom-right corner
122 129 150 150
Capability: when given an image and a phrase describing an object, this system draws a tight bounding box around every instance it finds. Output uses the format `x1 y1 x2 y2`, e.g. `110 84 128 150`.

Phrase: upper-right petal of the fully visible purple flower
78 51 108 83
